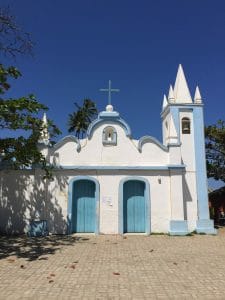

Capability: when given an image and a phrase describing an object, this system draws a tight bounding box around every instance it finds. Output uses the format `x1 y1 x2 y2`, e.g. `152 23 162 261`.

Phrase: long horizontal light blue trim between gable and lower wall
56 165 186 171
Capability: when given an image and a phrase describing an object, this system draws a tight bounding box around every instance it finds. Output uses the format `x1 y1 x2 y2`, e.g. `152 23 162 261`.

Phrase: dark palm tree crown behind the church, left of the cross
68 99 98 138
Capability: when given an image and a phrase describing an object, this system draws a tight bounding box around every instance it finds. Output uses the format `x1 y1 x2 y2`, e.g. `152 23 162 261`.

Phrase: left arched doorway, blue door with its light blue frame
68 176 99 233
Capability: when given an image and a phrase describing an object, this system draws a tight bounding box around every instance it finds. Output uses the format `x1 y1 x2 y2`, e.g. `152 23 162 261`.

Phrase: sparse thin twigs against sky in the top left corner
0 7 33 58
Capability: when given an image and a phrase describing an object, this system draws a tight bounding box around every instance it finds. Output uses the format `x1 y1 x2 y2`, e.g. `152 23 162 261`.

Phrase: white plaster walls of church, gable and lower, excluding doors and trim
0 108 197 234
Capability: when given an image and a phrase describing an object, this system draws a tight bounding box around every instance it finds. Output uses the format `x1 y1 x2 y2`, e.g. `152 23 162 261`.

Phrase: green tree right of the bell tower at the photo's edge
205 120 225 182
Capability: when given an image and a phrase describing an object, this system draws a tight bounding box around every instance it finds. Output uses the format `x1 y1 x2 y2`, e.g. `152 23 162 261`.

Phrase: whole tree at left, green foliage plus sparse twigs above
0 7 60 177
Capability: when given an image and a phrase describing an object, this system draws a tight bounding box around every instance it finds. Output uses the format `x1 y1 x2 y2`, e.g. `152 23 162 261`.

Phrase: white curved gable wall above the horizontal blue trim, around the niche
51 124 168 166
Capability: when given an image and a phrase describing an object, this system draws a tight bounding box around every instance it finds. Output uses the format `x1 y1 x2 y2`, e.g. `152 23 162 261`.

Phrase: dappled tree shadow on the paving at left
0 235 89 261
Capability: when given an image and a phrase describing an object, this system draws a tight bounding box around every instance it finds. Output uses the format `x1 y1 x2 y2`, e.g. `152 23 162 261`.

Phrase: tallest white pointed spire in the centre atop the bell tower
174 64 192 103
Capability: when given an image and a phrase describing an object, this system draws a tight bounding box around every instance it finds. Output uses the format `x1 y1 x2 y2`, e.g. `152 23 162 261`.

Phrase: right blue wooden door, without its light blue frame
123 180 145 232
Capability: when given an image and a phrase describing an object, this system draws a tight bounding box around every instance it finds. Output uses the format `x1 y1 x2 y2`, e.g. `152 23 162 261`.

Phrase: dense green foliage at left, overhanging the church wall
0 64 60 177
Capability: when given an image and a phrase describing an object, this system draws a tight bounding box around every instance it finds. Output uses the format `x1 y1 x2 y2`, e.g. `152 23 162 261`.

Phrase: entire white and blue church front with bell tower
0 65 216 235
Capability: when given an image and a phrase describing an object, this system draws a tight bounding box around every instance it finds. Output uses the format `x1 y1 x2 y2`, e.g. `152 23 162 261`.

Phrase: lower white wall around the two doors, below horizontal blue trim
0 170 191 234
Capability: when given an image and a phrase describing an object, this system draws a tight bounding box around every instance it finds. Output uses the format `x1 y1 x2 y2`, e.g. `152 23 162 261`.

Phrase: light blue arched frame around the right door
118 176 151 234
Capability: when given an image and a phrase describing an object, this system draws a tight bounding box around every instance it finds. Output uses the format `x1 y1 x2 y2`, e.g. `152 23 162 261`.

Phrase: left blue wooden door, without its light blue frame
72 180 96 232
